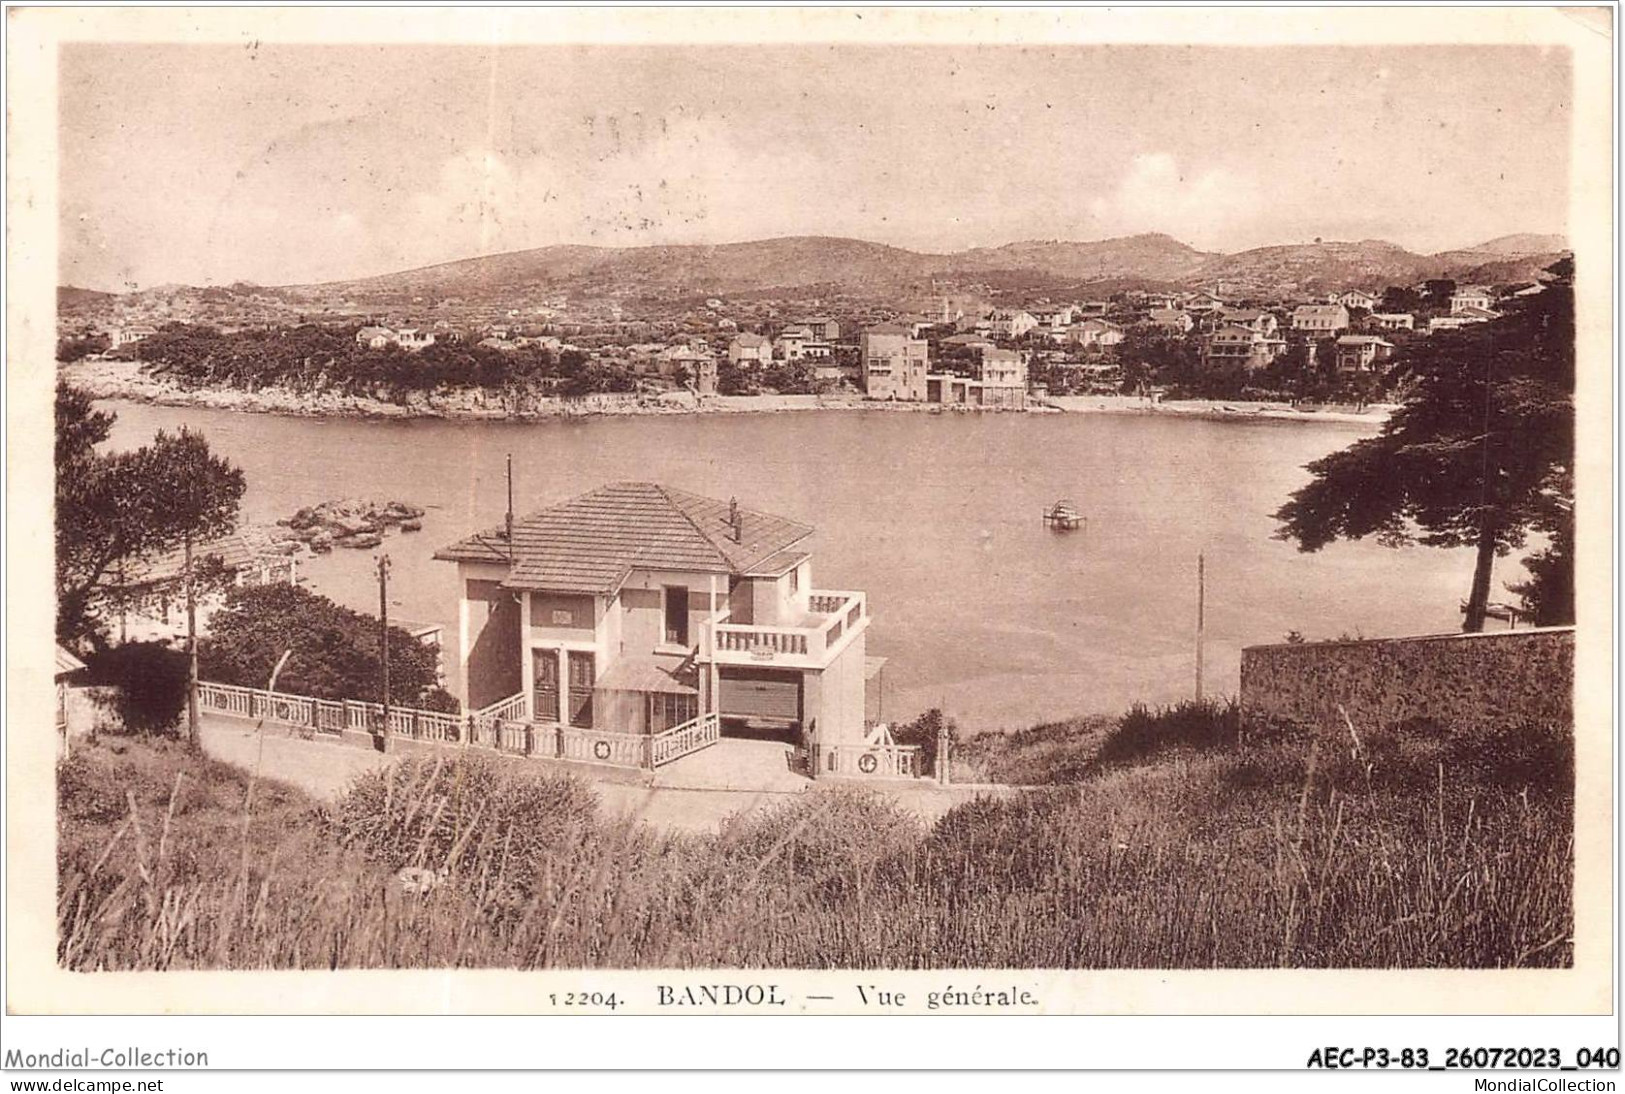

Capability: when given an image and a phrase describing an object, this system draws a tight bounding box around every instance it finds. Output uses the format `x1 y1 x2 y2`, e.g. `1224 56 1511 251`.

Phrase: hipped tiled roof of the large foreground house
436 483 813 595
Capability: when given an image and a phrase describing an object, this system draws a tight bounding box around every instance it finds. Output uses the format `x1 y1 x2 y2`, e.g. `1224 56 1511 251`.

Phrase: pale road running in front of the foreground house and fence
202 715 986 832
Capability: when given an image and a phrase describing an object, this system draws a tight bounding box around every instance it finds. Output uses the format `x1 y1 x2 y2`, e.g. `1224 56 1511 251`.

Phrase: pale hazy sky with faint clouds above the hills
59 44 1571 291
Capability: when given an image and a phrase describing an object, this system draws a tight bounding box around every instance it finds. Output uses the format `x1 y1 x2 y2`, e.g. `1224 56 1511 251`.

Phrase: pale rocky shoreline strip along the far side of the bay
57 361 1393 428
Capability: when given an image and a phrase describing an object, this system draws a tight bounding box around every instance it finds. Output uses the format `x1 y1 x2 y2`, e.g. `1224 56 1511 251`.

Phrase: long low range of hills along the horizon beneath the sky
59 232 1563 300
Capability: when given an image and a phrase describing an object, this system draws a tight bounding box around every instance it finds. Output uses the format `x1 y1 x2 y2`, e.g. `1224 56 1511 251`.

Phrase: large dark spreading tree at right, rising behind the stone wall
1276 262 1575 631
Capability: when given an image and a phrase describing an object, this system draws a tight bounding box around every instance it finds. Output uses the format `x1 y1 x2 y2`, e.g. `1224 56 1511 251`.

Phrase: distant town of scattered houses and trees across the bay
57 237 1557 410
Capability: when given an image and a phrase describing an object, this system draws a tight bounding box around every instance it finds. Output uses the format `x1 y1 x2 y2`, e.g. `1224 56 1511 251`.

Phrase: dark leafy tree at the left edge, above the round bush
55 384 245 644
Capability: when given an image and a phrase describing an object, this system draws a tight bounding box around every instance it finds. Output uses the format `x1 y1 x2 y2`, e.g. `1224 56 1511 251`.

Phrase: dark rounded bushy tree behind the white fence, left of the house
198 584 457 710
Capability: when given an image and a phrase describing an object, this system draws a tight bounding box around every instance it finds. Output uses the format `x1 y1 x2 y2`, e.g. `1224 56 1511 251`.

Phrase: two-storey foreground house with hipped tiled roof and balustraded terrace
436 483 869 766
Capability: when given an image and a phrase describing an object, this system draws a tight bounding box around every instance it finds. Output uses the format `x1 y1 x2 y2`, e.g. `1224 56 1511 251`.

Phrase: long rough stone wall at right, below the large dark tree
1242 627 1575 727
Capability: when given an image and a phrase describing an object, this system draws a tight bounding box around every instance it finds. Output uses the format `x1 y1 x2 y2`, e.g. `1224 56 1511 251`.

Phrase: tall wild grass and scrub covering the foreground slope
59 709 1573 969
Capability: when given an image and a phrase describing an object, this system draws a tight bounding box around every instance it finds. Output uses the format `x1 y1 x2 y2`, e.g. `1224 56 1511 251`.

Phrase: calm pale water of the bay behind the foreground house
107 402 1475 728
